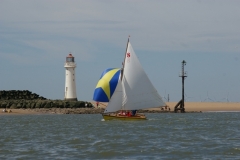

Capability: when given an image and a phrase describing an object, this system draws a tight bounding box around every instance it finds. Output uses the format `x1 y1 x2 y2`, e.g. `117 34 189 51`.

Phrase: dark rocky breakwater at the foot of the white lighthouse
0 90 104 114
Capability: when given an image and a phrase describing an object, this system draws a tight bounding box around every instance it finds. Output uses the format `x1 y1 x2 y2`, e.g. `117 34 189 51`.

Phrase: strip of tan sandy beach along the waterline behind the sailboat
0 102 240 115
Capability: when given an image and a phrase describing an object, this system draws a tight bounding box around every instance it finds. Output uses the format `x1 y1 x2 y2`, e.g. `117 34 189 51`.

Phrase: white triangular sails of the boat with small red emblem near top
105 42 165 113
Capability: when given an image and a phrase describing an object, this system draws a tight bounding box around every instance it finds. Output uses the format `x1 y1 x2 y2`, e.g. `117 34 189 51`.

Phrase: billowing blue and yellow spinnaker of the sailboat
93 68 121 102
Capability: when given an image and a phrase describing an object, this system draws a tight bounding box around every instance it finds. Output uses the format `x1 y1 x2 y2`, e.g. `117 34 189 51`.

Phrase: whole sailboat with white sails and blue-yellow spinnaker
93 38 166 120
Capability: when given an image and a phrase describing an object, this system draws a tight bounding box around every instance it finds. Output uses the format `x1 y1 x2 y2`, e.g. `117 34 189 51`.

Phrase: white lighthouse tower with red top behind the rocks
64 53 77 101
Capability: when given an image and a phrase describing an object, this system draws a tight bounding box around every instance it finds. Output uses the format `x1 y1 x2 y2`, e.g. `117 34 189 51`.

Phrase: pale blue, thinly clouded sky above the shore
0 0 240 102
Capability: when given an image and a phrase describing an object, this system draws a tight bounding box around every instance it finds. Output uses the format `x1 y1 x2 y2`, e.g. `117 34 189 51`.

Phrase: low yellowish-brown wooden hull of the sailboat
102 113 147 120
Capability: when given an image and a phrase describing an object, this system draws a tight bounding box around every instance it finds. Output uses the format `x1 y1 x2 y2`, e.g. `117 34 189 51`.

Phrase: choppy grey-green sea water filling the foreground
0 112 240 160
